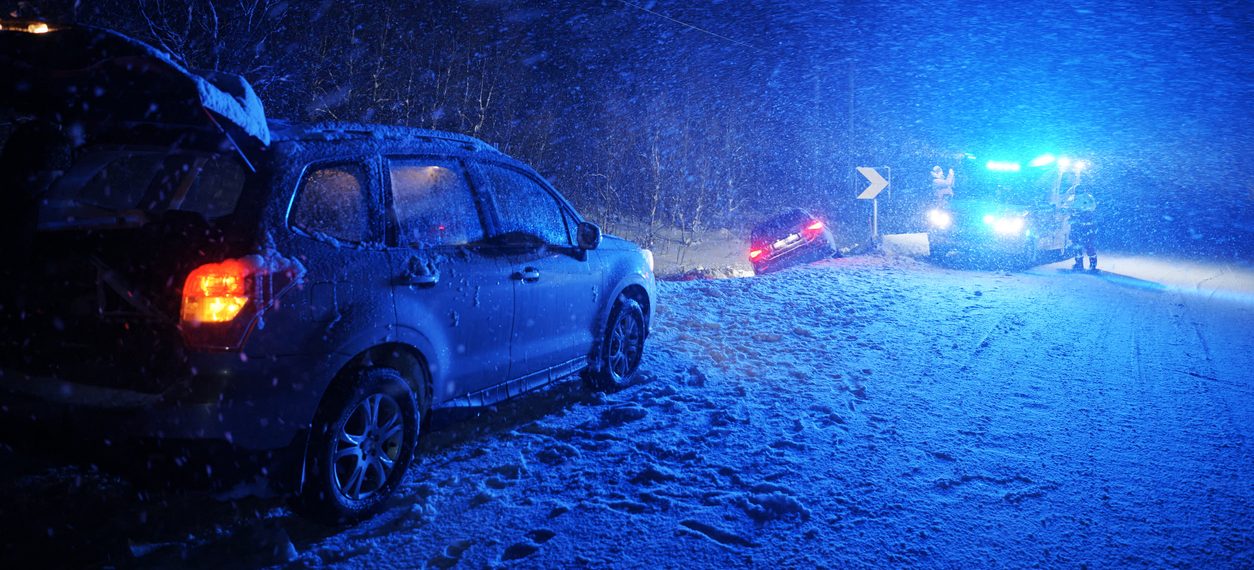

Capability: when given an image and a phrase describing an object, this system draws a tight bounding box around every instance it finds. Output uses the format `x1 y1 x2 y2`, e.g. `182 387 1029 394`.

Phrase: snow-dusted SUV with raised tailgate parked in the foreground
0 25 655 520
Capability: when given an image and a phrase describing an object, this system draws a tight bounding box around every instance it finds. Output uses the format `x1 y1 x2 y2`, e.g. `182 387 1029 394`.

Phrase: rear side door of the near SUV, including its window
385 157 514 403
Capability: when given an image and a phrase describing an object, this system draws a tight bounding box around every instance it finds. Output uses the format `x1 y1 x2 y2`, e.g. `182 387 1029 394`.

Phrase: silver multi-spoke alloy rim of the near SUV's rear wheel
331 393 405 501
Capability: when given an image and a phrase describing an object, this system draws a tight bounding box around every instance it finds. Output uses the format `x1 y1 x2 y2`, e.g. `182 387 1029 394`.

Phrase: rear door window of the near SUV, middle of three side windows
387 159 484 247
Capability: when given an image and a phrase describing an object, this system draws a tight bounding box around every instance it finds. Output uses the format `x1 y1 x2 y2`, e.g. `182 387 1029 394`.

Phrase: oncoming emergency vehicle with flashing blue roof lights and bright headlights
927 153 1090 267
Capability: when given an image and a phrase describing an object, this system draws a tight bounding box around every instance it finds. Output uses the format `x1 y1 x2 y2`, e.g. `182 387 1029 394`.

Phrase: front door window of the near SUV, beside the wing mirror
483 164 572 246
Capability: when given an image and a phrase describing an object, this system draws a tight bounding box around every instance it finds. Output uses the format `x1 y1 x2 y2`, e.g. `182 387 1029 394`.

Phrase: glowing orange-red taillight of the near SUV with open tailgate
178 256 305 350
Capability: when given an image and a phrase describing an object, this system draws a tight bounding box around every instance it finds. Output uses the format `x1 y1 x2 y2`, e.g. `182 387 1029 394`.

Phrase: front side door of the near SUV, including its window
474 162 606 386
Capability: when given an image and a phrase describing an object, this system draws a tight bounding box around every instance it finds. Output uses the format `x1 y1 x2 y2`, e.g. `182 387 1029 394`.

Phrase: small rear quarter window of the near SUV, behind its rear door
290 163 375 243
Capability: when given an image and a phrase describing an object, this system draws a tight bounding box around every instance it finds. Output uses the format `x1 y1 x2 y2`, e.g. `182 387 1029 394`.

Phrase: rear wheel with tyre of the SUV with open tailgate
296 368 421 524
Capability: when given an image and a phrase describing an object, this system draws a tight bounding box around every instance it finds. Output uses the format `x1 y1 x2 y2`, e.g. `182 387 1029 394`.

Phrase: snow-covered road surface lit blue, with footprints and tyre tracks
6 257 1254 567
